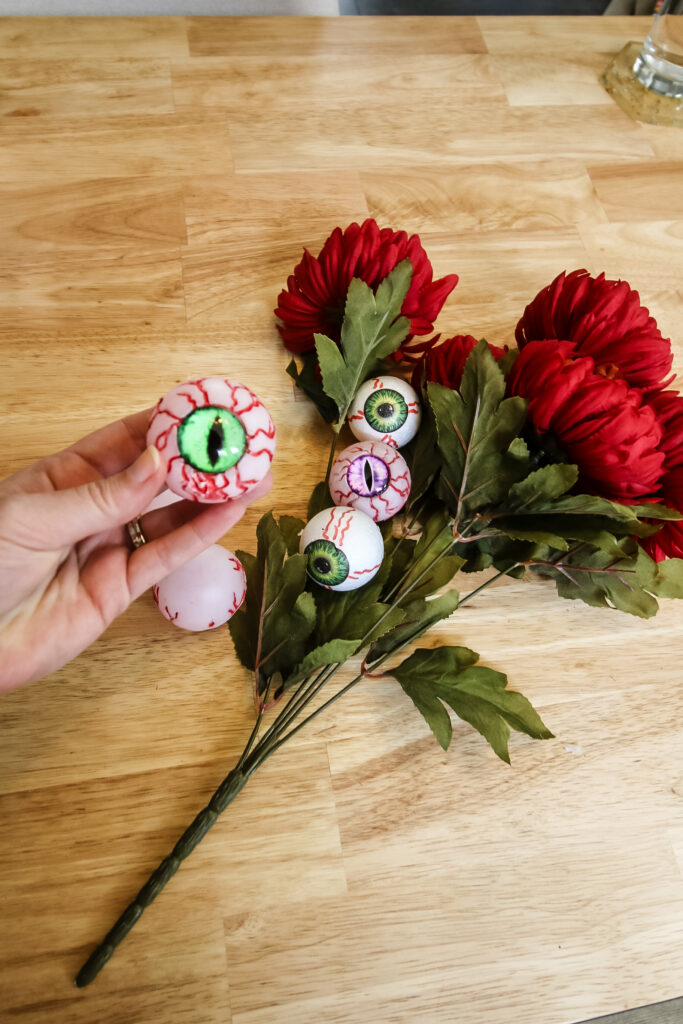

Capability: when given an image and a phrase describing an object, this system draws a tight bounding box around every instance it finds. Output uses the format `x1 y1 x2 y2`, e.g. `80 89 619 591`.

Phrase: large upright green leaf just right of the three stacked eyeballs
427 342 526 526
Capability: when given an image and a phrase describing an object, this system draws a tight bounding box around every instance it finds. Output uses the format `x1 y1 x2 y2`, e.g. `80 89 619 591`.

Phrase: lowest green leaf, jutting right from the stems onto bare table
391 647 552 763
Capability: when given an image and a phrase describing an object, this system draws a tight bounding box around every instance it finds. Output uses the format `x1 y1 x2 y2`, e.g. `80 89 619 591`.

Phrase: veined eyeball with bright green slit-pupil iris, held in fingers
147 377 275 502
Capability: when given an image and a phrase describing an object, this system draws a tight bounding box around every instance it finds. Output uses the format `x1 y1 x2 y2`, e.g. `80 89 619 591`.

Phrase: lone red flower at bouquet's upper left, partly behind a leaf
275 219 458 352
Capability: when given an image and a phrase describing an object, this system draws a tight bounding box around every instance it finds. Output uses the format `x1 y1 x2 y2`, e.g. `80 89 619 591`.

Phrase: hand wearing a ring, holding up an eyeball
0 410 272 691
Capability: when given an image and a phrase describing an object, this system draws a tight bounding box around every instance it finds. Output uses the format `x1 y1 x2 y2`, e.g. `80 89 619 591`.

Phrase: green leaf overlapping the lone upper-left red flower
315 260 413 427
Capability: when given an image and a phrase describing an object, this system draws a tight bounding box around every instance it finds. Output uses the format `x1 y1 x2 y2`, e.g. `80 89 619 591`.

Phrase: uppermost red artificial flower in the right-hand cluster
515 270 672 391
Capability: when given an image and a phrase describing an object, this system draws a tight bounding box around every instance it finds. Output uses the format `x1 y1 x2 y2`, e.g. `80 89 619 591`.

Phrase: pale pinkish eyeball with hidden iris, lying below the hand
152 544 247 633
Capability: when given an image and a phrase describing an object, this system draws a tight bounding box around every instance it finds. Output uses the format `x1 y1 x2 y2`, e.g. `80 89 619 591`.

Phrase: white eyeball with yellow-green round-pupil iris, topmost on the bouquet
348 377 422 447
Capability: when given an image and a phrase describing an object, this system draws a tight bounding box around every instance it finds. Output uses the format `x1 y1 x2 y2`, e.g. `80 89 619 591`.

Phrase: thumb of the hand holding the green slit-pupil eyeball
16 444 166 548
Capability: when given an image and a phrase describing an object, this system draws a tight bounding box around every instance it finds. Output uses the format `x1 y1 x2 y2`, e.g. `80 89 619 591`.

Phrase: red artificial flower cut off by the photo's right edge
641 391 683 562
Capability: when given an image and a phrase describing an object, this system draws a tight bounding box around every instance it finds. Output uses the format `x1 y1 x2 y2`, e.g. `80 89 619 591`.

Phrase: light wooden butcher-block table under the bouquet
0 17 683 1024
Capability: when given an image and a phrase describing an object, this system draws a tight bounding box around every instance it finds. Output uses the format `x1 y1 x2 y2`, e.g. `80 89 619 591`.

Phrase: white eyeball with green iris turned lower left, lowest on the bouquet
299 505 384 591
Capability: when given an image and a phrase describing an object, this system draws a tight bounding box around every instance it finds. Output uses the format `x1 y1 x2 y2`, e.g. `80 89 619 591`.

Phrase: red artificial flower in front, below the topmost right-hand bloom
508 341 665 502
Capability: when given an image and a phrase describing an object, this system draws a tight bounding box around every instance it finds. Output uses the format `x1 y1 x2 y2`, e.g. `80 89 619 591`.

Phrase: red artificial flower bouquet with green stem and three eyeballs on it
77 220 683 986
